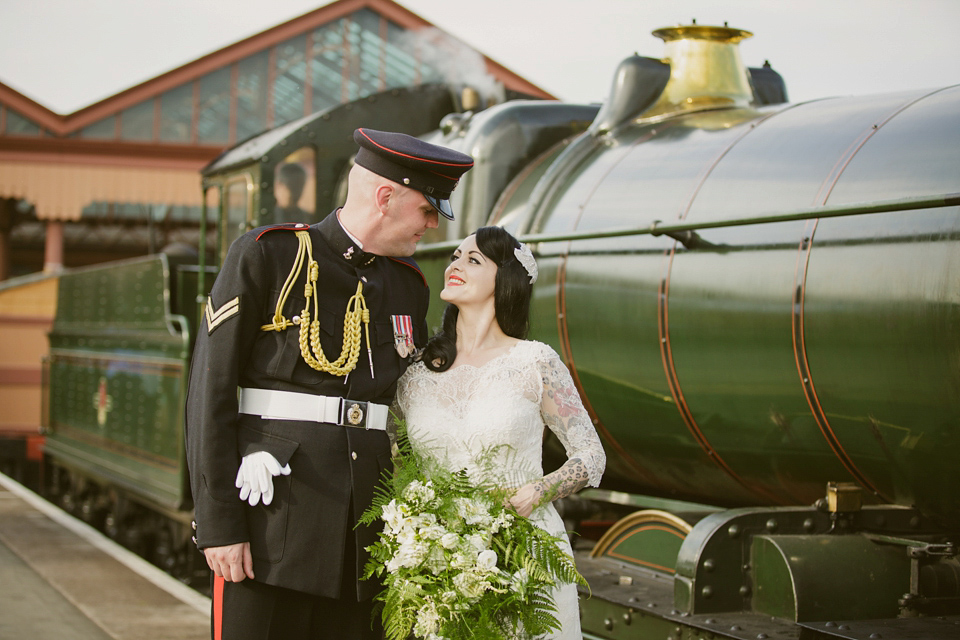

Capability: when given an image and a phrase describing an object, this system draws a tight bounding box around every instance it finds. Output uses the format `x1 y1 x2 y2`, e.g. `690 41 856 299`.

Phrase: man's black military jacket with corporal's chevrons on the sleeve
186 213 429 600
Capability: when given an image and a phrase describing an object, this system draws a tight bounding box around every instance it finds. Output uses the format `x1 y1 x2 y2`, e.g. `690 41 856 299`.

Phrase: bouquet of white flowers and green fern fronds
360 426 586 640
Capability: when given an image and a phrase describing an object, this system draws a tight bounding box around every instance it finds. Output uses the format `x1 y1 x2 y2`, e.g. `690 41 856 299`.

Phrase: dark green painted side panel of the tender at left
46 255 196 509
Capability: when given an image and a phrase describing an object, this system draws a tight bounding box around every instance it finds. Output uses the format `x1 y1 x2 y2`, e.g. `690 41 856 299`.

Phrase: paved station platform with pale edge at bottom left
0 475 210 640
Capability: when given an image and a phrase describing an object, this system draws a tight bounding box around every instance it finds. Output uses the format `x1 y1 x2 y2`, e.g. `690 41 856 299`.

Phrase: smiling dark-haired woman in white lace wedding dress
396 227 606 640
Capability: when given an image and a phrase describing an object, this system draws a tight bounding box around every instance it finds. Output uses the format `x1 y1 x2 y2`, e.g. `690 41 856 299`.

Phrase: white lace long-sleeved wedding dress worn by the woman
396 341 606 640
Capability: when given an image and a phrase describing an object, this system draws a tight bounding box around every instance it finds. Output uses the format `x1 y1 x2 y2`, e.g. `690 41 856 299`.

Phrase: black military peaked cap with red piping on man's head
353 128 473 220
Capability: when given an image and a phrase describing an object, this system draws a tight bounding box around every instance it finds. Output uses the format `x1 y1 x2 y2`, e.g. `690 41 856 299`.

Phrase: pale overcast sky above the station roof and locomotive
0 0 960 114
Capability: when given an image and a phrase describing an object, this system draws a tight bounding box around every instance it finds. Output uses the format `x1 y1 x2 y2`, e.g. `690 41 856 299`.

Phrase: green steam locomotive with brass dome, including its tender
39 25 960 640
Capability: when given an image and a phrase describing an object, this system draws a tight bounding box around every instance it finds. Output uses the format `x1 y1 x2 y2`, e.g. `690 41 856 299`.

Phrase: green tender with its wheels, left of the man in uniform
44 254 206 577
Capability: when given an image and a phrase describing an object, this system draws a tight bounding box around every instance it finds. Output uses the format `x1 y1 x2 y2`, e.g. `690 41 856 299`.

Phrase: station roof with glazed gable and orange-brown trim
0 0 552 221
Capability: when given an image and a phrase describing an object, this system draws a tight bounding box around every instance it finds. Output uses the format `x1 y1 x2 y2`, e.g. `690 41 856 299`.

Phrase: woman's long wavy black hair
422 227 533 371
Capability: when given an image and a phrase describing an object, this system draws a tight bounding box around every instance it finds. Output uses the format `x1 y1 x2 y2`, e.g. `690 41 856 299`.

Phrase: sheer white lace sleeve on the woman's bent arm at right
537 345 607 490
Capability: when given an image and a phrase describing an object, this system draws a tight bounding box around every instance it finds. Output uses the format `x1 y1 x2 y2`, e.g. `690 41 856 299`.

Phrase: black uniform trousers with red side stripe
210 578 383 640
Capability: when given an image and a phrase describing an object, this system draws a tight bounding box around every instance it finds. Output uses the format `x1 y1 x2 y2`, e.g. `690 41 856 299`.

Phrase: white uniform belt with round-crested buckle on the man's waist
240 389 389 431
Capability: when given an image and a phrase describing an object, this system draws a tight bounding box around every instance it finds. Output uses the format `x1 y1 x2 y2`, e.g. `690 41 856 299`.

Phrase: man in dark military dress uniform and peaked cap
186 129 473 640
